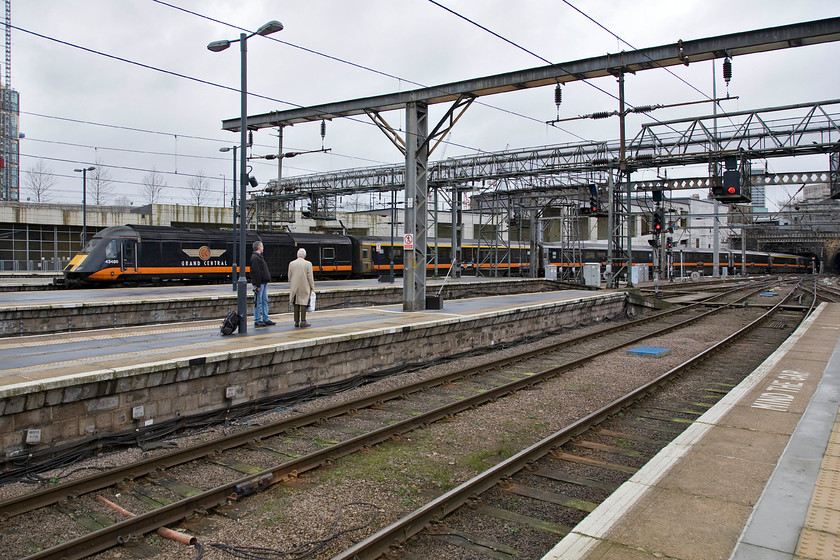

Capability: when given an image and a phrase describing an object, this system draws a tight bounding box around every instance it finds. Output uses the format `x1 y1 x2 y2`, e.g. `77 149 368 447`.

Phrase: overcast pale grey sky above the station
11 0 840 209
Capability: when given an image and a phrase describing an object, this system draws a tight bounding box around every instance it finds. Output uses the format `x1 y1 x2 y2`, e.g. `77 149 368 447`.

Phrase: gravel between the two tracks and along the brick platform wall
0 308 760 560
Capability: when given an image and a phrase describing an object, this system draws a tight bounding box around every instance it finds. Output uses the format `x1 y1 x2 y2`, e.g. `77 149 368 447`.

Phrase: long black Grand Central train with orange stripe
64 226 811 286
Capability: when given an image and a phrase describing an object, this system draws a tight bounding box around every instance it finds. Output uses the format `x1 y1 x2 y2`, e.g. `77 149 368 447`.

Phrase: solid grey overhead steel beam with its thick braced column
222 18 840 310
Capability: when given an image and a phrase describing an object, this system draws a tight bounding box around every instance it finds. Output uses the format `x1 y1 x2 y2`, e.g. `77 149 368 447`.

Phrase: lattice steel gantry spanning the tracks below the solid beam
266 100 840 200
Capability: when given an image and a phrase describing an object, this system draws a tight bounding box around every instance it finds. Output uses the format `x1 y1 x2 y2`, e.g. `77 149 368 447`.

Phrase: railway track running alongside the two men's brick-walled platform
0 278 808 559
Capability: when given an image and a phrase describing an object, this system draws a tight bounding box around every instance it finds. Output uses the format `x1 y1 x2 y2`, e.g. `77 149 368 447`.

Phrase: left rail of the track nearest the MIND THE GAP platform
332 291 793 560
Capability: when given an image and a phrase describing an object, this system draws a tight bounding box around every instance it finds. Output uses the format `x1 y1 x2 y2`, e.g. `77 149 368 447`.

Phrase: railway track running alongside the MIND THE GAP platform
333 284 808 560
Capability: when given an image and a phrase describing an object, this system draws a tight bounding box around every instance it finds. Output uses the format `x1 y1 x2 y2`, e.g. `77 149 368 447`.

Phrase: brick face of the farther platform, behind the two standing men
0 279 568 336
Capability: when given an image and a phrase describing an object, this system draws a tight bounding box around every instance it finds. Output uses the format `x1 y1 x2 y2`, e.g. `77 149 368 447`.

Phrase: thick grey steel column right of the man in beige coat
403 101 429 311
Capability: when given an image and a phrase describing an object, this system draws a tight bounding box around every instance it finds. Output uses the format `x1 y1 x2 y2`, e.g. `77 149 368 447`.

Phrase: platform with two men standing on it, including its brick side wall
0 286 627 457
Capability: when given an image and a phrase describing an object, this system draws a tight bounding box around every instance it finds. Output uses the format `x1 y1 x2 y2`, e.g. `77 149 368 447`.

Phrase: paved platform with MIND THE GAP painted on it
543 303 840 560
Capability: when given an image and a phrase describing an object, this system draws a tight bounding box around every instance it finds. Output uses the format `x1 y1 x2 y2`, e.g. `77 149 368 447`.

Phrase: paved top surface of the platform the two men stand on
0 290 596 396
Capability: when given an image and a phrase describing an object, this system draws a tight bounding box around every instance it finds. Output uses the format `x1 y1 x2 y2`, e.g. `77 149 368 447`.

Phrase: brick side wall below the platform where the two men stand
0 293 626 456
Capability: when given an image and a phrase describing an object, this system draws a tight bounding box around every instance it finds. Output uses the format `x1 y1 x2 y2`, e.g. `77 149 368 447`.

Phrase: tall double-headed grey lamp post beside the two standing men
207 20 283 334
